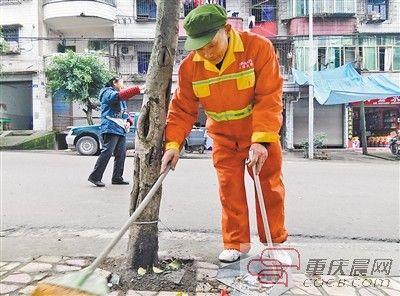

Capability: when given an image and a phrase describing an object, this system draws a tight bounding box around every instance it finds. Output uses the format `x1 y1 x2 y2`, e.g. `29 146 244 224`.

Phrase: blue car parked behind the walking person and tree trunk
65 112 206 155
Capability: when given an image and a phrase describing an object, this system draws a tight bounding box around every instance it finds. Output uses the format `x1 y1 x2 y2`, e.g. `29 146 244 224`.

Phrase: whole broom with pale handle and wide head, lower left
32 166 170 296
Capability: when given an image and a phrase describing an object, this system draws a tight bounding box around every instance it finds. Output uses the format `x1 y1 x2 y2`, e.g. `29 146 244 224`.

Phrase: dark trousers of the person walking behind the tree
89 133 126 182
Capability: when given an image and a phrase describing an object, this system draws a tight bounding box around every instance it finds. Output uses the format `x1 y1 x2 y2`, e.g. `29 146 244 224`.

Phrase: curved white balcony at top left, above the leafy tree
43 0 117 30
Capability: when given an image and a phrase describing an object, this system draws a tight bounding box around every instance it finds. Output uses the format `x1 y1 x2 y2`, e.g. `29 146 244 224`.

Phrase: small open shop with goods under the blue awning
349 97 400 148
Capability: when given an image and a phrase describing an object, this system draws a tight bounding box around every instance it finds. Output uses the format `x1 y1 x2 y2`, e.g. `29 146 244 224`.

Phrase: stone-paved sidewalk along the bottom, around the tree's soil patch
0 256 400 296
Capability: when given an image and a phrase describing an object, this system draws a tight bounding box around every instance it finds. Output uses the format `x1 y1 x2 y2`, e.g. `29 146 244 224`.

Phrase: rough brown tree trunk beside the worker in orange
128 0 180 269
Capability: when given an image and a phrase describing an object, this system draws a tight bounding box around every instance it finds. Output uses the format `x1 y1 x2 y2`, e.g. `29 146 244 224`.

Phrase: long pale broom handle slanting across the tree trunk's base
86 166 171 275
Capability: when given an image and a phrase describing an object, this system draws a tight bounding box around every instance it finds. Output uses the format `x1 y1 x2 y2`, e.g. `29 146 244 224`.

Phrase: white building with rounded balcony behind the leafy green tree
0 0 117 130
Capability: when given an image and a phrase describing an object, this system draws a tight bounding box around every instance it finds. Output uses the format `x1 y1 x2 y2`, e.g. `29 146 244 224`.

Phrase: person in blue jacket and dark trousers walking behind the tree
88 77 144 187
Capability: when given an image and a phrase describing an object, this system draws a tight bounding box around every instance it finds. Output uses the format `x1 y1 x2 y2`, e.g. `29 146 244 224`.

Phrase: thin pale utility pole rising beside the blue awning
308 0 314 159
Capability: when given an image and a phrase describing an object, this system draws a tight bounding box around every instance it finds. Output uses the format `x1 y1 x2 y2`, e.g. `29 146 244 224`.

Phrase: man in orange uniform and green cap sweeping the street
161 4 288 262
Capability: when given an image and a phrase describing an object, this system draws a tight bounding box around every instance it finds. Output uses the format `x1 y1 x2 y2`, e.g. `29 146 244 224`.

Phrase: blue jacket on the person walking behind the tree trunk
99 87 129 136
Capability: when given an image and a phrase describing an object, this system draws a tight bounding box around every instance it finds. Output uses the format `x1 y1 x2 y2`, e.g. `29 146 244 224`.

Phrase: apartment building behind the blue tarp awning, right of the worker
278 0 400 148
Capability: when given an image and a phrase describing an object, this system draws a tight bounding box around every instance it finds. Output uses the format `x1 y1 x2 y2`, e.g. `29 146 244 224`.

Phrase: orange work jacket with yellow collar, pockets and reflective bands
166 29 283 149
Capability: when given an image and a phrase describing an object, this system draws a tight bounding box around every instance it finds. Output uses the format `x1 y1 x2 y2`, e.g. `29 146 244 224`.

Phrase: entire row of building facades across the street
0 0 400 148
